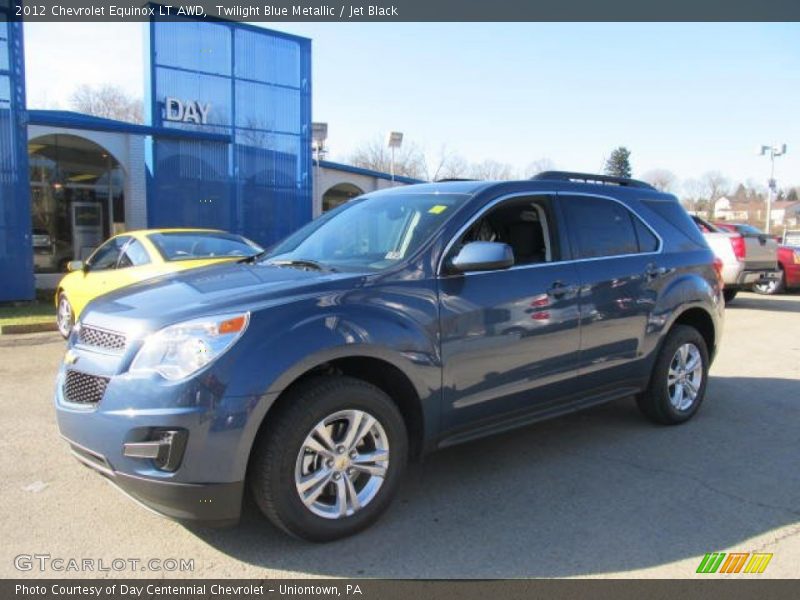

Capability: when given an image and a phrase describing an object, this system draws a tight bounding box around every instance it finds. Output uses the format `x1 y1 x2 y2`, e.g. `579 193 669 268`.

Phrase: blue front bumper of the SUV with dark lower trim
55 353 258 526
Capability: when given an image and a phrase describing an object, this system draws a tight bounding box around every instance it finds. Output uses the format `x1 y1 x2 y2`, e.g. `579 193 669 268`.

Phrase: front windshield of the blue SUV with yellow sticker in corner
263 194 469 270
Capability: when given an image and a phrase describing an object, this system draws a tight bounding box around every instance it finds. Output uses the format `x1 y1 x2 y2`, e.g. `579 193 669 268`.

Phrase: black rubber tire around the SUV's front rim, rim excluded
255 377 408 542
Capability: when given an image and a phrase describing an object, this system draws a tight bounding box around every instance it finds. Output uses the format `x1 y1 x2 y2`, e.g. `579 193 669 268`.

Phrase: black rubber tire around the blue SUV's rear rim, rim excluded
648 325 709 424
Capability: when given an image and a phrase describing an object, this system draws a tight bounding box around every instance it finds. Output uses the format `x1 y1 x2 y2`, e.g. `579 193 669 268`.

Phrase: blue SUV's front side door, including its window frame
439 198 580 433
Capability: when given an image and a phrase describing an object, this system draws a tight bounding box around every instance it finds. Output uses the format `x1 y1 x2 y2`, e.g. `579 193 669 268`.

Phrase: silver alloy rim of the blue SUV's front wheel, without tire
295 410 389 519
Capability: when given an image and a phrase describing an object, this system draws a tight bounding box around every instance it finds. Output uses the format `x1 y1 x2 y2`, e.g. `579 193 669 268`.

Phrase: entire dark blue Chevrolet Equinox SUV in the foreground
55 172 724 541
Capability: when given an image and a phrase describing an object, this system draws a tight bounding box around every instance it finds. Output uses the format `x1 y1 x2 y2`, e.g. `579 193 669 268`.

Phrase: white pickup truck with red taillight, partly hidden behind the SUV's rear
692 215 781 302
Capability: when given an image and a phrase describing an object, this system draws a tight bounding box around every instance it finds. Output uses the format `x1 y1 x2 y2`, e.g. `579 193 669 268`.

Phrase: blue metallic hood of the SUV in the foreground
81 263 365 332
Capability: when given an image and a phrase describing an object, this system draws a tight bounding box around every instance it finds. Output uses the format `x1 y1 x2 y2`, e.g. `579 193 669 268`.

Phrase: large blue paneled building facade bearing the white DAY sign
146 19 312 245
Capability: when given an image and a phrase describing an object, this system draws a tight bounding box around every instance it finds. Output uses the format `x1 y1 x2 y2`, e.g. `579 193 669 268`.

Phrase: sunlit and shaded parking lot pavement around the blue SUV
0 294 800 578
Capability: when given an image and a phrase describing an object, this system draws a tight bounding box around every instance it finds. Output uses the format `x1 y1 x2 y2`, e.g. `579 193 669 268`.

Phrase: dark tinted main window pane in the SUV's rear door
563 196 639 258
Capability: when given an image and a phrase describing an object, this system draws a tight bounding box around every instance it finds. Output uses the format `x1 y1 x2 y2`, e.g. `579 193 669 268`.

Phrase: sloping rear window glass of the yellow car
148 231 261 261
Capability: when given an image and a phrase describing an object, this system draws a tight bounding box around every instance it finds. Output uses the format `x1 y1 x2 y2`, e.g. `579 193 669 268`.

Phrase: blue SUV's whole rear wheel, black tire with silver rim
636 325 709 425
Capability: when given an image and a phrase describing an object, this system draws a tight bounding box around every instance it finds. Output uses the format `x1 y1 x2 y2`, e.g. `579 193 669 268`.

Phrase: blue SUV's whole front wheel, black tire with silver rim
249 376 408 542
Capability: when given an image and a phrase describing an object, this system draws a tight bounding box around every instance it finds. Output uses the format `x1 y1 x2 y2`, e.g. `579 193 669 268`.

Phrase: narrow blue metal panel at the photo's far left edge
0 14 34 301
